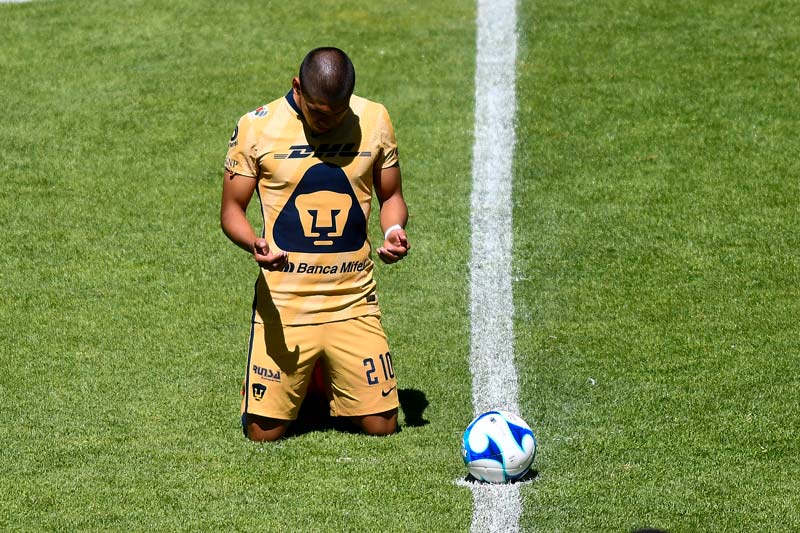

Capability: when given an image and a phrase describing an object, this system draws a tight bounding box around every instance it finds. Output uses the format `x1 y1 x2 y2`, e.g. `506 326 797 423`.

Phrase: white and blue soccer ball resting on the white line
461 409 536 483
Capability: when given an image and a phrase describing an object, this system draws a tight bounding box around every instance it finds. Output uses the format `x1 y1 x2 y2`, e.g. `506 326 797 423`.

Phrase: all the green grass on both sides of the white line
0 0 800 532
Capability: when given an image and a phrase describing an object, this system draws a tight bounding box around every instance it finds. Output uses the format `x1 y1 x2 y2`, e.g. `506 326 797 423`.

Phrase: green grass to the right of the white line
514 1 800 532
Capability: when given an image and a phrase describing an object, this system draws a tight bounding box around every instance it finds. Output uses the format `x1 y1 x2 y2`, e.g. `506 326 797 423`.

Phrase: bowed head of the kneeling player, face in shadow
292 47 356 133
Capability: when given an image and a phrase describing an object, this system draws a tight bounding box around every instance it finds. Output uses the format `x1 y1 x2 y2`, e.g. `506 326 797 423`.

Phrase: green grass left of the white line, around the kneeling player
0 1 474 531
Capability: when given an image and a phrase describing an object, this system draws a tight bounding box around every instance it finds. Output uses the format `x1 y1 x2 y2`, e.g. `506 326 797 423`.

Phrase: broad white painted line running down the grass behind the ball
470 0 522 533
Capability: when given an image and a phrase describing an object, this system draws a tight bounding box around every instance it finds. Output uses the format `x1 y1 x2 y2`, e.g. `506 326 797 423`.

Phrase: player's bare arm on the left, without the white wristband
219 170 288 270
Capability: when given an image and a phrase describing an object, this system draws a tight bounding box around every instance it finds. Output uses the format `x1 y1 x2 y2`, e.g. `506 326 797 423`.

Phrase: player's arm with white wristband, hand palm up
372 165 411 263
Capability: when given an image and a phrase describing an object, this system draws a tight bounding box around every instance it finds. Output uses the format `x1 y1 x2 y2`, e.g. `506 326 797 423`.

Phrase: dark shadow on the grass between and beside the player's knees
287 389 430 437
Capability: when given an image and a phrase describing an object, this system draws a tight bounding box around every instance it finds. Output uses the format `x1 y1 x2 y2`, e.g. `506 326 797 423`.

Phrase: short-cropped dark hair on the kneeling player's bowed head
300 46 356 102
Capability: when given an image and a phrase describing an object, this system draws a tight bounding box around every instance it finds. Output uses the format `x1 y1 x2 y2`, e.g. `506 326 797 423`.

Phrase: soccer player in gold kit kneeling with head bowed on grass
220 48 411 441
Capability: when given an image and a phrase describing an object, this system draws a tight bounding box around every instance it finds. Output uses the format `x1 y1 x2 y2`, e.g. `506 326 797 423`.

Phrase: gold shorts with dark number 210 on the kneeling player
242 316 400 420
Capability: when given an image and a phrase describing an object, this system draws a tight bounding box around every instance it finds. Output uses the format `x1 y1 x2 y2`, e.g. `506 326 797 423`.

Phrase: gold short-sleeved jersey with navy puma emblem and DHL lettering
225 91 398 325
